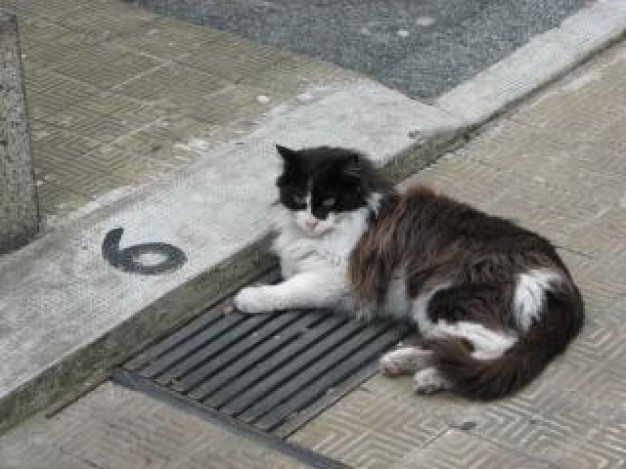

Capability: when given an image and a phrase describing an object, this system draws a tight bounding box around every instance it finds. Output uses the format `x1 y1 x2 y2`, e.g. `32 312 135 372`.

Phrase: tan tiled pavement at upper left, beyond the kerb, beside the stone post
0 0 355 227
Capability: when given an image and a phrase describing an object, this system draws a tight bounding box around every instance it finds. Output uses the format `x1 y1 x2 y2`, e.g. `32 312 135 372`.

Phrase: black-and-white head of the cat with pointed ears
276 145 391 237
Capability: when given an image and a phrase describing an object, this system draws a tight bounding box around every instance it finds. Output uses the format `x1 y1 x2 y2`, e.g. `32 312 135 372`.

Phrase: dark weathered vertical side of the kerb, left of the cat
0 232 276 435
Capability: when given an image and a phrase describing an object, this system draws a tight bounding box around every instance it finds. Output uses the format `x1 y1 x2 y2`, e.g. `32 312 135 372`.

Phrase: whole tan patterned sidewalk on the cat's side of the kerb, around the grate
0 34 626 469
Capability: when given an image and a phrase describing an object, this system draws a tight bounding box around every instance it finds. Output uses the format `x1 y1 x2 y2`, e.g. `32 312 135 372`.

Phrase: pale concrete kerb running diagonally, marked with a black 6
0 0 626 432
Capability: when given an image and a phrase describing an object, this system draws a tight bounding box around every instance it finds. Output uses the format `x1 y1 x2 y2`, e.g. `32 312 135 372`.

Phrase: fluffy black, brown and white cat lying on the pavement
234 146 584 400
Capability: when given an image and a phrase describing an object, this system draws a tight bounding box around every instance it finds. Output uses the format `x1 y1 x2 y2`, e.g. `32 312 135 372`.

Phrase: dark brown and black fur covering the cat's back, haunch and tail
348 186 583 399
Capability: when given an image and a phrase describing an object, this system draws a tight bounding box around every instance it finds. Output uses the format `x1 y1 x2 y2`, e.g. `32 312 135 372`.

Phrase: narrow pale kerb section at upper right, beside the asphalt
433 0 626 124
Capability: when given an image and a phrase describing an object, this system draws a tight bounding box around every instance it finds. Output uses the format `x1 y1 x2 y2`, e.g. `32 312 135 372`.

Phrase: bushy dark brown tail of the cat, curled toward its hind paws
425 285 583 401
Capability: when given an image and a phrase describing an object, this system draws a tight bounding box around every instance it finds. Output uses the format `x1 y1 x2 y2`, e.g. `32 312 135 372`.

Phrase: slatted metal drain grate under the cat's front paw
119 273 408 437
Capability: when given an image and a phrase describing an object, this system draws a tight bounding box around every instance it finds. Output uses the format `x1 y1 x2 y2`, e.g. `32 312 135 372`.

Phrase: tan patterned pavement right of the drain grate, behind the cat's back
292 42 626 469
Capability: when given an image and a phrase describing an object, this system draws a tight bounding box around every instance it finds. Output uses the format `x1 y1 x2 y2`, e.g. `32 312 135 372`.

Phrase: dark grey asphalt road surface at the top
133 0 586 100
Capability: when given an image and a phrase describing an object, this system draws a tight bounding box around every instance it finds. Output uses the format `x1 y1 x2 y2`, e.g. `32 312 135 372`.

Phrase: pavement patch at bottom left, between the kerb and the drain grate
0 384 308 469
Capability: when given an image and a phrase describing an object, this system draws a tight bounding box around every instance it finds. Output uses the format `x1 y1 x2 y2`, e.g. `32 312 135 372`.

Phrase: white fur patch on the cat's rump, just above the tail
513 269 562 330
